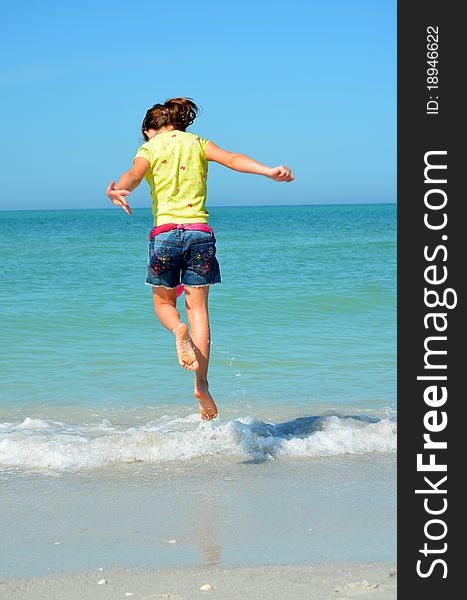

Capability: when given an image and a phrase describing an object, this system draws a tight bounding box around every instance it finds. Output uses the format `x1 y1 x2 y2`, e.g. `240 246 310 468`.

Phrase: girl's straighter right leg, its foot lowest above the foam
185 286 218 420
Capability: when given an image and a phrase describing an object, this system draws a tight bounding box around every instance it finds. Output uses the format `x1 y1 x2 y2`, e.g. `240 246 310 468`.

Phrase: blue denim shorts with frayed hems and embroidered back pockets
146 229 221 288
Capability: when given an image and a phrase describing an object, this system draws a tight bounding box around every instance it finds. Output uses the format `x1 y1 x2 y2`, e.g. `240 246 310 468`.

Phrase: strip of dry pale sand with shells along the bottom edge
0 563 397 600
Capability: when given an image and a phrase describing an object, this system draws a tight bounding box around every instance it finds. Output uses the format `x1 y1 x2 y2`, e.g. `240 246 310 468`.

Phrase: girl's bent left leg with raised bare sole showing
152 286 199 371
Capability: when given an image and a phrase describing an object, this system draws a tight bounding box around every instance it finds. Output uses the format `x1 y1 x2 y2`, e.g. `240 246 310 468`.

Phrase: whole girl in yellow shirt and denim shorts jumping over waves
106 98 294 420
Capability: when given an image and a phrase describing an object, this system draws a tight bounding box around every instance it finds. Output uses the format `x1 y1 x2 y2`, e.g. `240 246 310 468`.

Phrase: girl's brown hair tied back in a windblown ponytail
141 98 199 141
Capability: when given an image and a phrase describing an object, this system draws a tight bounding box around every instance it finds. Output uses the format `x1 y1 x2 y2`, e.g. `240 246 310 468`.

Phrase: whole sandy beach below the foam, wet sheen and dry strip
0 455 396 600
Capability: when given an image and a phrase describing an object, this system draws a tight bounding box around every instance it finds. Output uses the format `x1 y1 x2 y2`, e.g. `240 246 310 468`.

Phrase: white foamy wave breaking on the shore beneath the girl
0 414 397 471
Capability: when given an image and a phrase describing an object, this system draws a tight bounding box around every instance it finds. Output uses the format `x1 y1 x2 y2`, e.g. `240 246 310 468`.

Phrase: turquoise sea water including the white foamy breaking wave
0 205 396 470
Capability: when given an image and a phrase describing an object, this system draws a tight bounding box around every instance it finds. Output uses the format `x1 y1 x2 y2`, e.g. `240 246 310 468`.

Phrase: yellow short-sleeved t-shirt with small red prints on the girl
133 129 209 225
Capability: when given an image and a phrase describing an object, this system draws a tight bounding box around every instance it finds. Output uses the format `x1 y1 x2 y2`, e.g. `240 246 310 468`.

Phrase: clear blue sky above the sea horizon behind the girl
0 0 396 210
